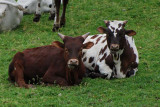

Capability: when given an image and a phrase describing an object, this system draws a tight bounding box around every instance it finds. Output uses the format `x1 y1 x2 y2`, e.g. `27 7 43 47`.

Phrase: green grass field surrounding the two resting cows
0 0 160 107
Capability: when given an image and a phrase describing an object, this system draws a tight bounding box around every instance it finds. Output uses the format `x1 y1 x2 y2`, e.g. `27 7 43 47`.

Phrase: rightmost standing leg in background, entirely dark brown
60 0 68 26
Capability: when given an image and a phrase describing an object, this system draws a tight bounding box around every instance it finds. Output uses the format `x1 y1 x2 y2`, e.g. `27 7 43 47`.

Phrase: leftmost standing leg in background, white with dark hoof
33 0 42 22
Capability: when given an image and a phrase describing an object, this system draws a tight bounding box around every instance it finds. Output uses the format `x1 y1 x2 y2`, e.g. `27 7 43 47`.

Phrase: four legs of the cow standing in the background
33 0 68 32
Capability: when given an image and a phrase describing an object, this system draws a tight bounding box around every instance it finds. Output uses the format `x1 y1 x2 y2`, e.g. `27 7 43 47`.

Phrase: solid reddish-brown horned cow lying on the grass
9 33 92 88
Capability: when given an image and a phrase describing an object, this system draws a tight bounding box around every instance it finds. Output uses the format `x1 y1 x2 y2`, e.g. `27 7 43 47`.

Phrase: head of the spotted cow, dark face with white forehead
98 20 136 53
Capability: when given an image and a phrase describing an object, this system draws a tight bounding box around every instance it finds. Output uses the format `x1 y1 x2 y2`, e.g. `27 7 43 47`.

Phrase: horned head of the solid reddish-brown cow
52 33 93 69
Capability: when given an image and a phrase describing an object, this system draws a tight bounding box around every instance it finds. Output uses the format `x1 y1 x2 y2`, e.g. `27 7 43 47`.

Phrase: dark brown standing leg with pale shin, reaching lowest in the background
52 0 61 32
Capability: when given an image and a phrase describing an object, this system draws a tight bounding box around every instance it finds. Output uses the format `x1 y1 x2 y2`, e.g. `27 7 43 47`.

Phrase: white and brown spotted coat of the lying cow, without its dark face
82 21 139 79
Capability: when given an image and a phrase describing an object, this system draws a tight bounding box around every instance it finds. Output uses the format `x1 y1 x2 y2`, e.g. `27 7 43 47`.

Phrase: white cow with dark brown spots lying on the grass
82 20 139 79
